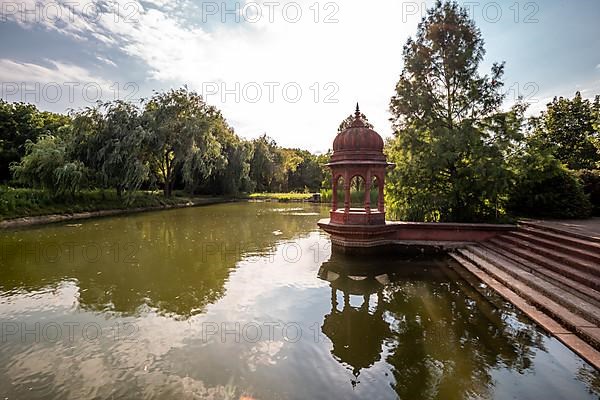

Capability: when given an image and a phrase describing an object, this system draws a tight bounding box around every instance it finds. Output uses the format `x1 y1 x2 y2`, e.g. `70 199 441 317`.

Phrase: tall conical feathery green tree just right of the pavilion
387 1 523 221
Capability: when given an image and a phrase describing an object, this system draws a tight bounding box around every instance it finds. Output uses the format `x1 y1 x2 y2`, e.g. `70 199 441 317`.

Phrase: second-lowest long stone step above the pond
458 245 600 326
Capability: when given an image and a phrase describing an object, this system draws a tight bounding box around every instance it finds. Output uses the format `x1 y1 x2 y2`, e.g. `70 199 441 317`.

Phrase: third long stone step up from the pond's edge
481 242 600 307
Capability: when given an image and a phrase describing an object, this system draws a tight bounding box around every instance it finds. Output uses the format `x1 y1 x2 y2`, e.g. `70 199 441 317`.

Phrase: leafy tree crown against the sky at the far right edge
531 92 600 170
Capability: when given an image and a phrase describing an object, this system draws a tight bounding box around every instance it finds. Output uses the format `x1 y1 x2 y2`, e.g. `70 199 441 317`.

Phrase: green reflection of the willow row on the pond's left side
0 203 328 318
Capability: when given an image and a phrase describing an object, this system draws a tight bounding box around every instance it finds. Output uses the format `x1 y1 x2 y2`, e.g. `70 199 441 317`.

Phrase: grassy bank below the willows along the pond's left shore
0 186 225 220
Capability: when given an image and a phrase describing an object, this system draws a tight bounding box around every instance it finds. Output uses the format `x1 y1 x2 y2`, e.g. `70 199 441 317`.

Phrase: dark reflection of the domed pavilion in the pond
319 255 391 376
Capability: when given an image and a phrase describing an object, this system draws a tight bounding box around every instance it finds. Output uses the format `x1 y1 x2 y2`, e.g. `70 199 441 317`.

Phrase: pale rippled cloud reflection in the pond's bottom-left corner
7 343 236 400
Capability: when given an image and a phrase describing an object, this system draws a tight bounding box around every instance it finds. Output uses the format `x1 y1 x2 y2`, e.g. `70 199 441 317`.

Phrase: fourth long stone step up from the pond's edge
488 238 600 291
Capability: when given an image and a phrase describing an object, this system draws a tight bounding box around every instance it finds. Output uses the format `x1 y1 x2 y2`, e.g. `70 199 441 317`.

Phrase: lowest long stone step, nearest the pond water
451 253 600 349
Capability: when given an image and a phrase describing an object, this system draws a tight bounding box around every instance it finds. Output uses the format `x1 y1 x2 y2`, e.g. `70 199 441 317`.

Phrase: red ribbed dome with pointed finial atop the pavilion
331 104 385 163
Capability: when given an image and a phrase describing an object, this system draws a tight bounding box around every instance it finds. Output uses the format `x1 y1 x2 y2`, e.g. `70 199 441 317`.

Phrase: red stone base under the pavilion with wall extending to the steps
318 218 516 253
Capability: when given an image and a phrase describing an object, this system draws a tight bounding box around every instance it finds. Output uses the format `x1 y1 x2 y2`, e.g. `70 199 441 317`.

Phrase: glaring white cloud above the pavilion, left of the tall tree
1 0 426 150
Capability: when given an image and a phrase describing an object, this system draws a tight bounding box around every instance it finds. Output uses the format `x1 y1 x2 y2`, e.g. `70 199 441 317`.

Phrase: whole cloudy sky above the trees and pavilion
0 0 600 151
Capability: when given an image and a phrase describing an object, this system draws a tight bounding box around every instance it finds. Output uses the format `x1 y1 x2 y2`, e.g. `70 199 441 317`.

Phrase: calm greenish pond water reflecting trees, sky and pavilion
0 203 600 400
